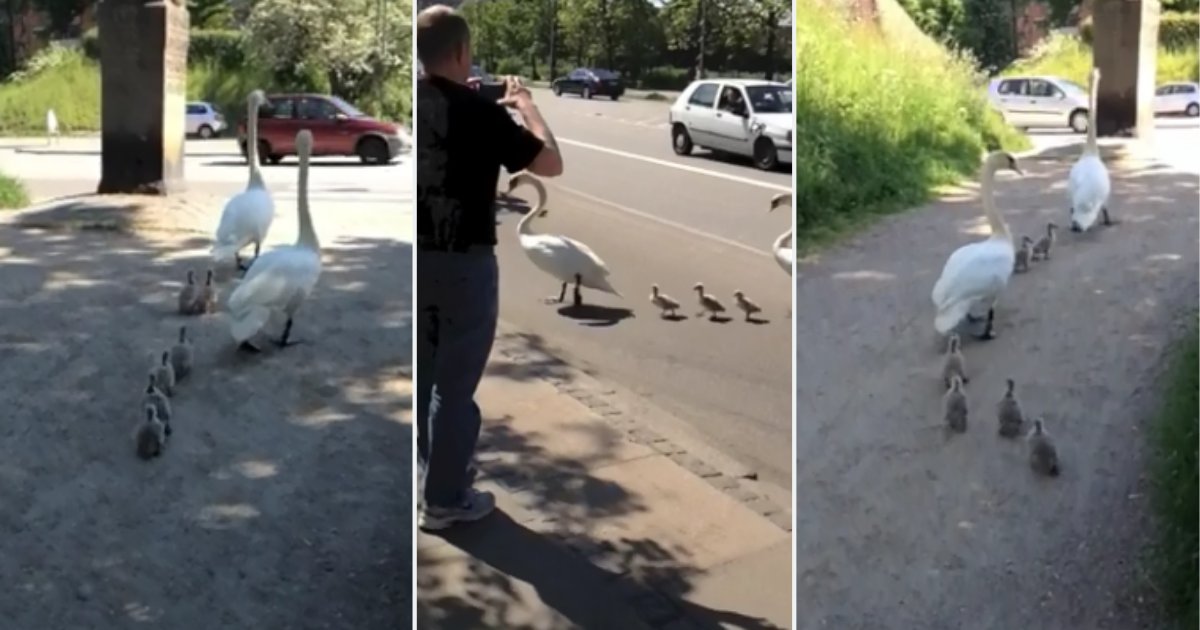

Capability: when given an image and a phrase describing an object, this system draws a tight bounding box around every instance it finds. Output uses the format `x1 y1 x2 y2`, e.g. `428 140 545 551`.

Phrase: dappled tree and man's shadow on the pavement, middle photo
416 334 776 630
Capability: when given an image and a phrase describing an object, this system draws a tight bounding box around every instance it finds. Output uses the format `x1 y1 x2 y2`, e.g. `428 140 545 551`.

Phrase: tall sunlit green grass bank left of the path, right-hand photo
793 0 1030 250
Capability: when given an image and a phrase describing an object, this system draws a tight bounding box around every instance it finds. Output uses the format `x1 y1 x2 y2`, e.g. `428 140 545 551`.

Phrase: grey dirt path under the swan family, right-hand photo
794 145 1200 630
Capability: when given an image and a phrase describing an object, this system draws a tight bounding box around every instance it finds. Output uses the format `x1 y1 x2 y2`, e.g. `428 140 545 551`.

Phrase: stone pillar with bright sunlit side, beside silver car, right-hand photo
1092 0 1160 139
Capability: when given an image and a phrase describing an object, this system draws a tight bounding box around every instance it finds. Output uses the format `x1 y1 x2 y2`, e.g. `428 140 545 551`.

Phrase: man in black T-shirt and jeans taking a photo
416 5 563 529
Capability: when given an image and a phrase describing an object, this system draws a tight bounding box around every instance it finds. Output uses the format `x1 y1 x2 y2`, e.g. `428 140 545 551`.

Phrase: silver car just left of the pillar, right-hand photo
988 77 1087 133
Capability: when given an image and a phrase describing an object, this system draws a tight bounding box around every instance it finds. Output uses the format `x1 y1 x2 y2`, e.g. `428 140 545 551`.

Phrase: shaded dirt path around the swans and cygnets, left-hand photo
0 217 412 630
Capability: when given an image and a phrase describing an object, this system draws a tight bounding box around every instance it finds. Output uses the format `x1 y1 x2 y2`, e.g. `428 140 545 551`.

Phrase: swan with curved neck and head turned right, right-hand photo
931 151 1024 338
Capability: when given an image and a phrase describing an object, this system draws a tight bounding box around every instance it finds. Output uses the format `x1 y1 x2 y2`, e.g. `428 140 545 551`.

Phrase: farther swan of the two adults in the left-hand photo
212 90 275 271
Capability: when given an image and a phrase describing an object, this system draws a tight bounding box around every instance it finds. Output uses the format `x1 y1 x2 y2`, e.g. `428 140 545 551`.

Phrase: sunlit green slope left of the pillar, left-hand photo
0 49 100 136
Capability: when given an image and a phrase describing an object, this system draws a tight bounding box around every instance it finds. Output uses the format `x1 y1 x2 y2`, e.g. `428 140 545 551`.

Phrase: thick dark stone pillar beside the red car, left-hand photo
98 0 188 194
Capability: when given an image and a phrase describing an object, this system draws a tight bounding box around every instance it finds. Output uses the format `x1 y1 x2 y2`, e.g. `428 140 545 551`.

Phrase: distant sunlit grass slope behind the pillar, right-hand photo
1002 34 1200 85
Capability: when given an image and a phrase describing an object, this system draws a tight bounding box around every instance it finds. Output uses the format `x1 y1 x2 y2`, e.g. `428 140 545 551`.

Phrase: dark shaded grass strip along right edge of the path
1150 324 1200 629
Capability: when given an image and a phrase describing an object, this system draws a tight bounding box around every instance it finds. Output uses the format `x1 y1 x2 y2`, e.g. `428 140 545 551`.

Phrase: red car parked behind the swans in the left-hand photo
238 94 401 164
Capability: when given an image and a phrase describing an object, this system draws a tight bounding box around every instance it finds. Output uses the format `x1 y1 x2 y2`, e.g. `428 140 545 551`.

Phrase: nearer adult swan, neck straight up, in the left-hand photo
228 130 320 352
